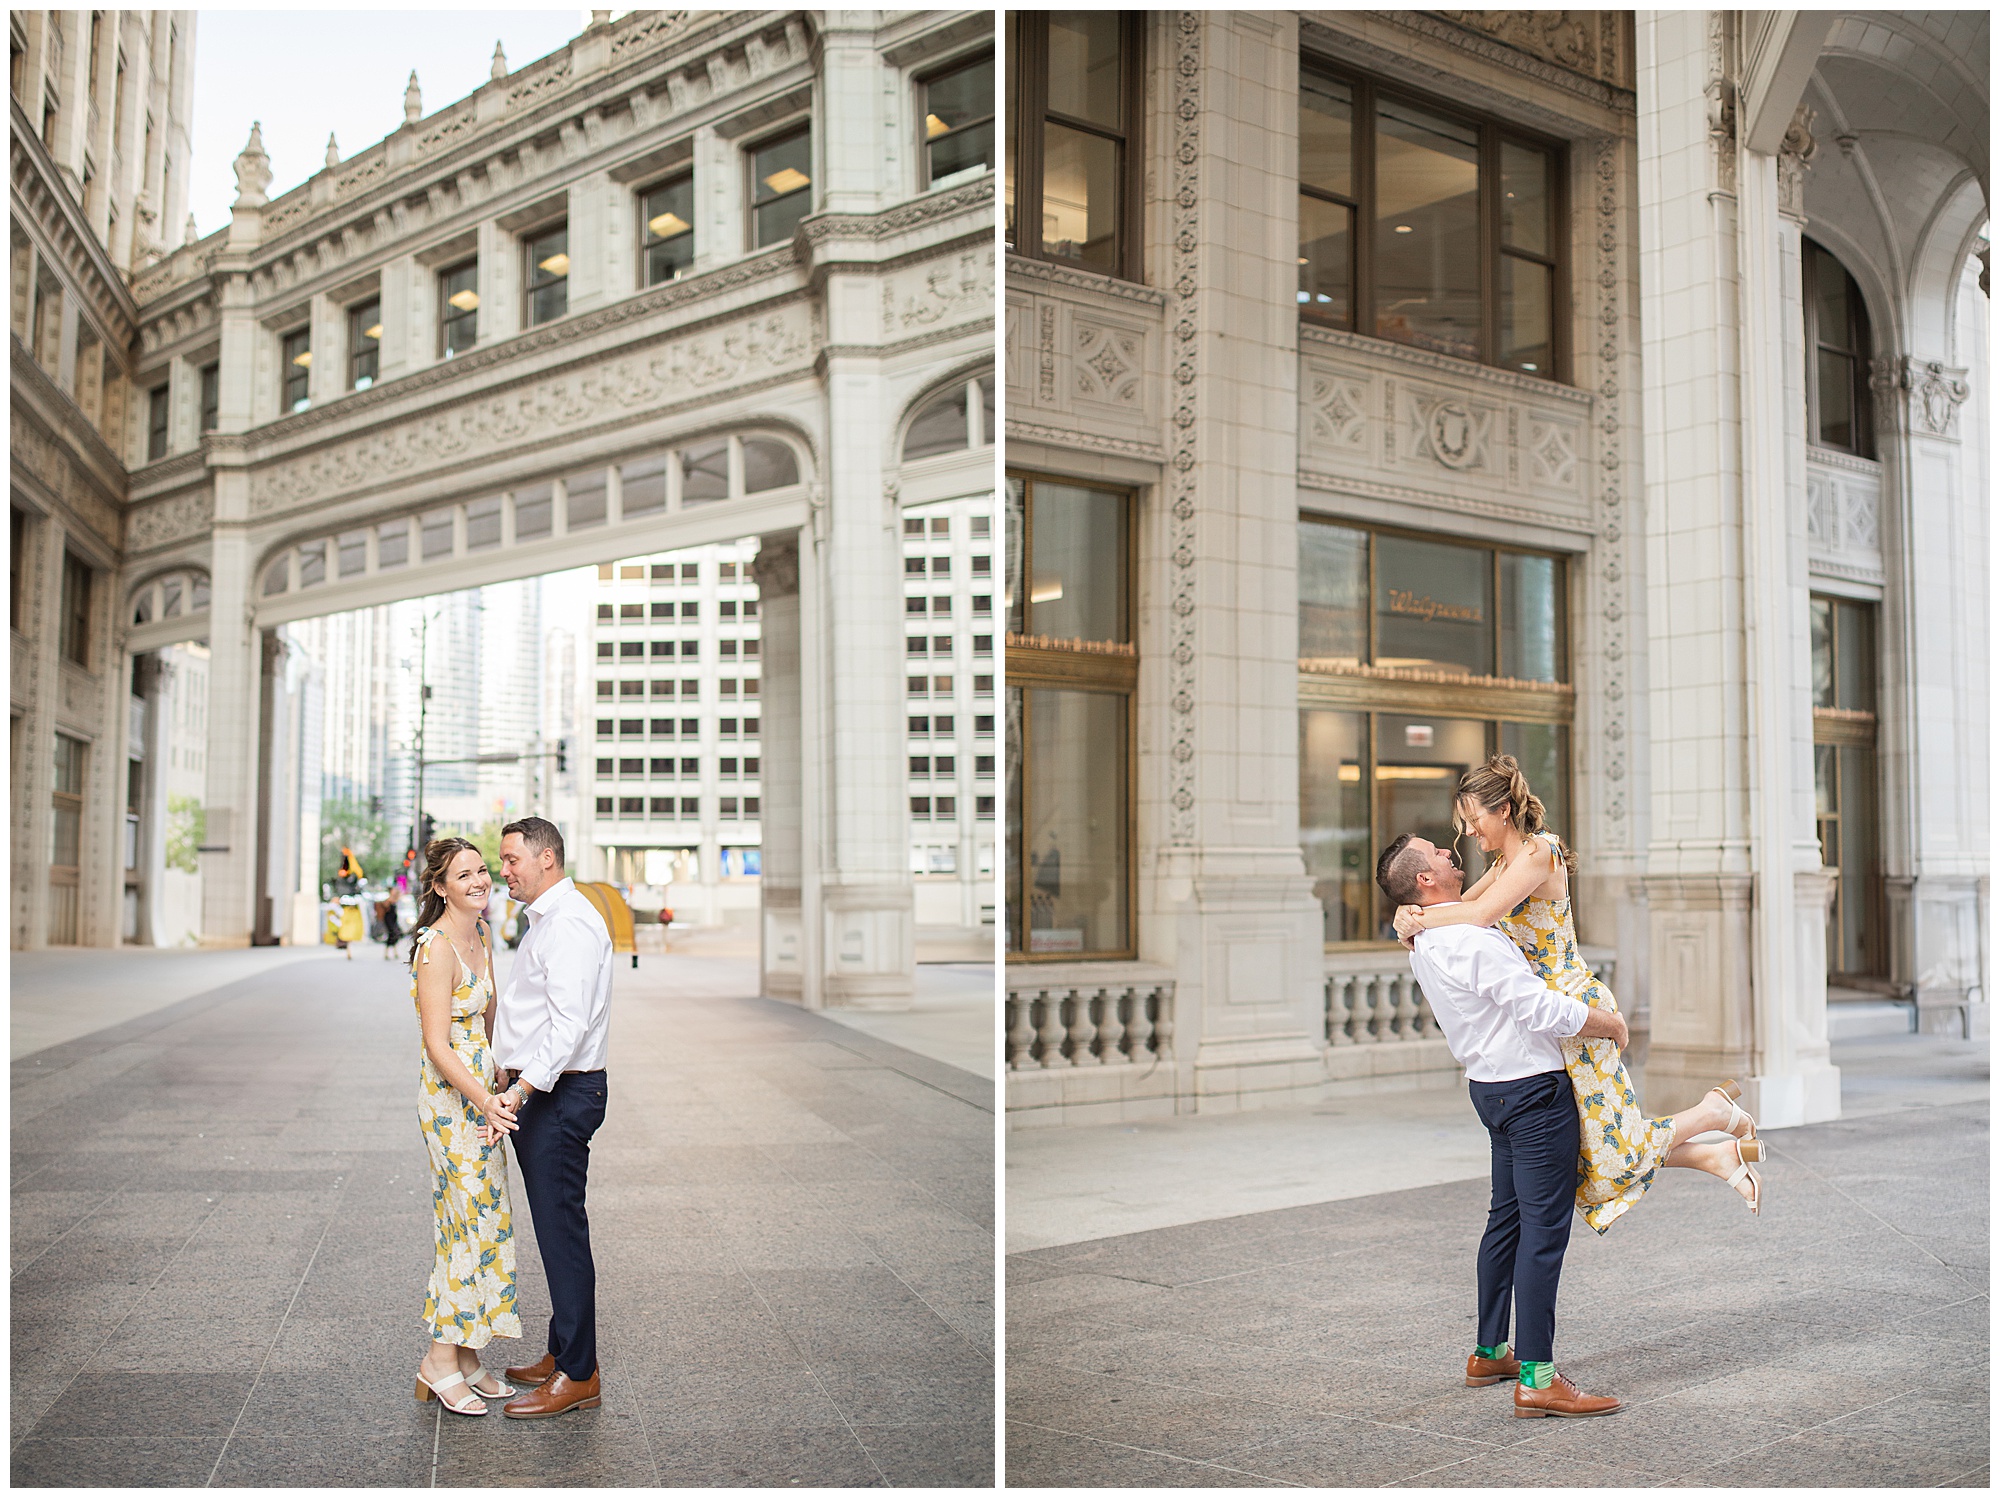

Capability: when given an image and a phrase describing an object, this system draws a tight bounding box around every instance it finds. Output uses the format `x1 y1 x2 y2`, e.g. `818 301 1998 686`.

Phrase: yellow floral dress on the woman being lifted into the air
1500 834 1674 1234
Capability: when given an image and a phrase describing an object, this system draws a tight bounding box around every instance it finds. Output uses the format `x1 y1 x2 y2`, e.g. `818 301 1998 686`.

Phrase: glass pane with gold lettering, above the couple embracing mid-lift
1374 536 1494 676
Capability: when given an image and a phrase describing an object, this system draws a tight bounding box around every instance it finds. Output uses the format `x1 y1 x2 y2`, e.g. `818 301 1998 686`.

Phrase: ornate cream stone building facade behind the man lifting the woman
1004 12 1986 1126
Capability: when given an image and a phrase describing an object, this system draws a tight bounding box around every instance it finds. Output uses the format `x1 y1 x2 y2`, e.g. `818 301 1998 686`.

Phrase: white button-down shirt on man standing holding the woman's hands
494 878 612 1092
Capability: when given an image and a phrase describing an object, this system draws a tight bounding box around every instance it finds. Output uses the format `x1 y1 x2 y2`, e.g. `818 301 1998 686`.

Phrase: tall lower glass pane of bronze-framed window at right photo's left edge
1010 688 1132 956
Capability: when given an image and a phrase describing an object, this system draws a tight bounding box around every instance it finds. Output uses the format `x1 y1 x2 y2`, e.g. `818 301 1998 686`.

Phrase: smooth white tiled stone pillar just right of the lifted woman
1638 12 1840 1128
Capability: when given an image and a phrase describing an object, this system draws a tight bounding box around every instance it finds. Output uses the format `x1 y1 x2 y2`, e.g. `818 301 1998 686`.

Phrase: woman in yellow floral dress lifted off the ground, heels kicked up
1396 754 1764 1234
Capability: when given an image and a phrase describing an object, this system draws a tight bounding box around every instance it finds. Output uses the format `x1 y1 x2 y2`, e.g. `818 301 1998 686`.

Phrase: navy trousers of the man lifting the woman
1472 1072 1578 1362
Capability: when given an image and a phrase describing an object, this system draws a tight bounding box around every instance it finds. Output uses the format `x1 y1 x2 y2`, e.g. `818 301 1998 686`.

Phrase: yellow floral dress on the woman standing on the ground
410 926 520 1348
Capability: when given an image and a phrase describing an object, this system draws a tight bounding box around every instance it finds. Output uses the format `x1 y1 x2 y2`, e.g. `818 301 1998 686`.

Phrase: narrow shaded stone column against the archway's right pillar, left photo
750 532 804 1000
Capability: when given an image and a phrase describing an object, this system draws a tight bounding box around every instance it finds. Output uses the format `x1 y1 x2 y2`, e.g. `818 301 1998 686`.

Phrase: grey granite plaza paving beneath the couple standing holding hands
10 948 994 1486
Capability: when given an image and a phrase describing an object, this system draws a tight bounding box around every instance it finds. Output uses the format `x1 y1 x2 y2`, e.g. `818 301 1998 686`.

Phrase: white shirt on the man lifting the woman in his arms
1410 904 1590 1082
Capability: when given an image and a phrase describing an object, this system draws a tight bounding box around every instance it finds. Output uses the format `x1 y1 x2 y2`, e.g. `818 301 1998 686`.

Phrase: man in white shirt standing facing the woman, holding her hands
488 816 612 1420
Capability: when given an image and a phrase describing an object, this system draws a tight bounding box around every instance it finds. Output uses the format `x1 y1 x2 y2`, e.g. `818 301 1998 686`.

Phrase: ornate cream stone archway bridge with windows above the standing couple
16 12 994 1004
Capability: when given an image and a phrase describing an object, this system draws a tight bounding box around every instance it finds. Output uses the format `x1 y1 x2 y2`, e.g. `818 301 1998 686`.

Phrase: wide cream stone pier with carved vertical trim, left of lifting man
1138 10 1326 1110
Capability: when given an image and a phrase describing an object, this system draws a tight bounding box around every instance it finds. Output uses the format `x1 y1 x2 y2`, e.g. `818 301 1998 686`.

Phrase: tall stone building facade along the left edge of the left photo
8 10 194 948
